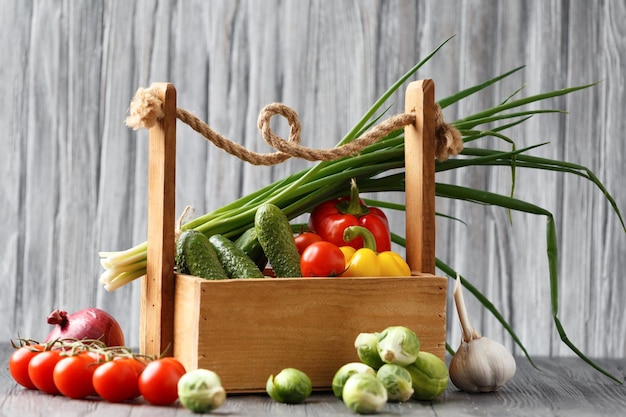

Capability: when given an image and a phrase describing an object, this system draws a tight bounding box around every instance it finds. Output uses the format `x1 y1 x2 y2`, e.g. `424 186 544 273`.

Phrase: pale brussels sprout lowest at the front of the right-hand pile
343 373 387 414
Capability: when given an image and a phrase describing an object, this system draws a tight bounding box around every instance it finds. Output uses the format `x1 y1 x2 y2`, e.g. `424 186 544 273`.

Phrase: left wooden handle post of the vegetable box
140 83 176 355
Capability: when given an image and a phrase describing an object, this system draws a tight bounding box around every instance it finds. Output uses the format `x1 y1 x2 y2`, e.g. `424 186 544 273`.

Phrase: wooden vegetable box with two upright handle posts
140 80 447 393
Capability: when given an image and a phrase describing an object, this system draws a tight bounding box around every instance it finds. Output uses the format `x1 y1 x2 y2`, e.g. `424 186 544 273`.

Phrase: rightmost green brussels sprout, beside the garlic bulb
406 352 449 401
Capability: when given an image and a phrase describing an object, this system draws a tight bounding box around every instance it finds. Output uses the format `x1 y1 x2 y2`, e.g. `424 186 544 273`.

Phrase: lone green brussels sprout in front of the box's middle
265 368 313 404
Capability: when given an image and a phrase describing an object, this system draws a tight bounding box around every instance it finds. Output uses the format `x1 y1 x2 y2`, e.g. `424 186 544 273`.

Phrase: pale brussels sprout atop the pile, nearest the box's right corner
378 326 420 366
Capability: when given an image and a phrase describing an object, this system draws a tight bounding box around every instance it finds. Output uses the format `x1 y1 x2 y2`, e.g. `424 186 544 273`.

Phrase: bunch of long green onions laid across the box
99 39 626 382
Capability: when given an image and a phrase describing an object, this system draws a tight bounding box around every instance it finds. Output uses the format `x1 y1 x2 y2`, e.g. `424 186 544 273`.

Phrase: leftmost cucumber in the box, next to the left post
176 229 228 279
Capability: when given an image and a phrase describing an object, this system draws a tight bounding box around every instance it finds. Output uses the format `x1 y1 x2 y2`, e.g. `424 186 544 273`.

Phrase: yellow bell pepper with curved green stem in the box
340 226 411 277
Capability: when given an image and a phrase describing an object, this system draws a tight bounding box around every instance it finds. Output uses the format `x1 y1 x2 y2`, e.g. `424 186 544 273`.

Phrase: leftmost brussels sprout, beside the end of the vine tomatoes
178 369 226 413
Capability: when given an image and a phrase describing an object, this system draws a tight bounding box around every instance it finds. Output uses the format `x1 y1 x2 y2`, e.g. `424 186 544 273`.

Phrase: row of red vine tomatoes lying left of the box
9 339 193 405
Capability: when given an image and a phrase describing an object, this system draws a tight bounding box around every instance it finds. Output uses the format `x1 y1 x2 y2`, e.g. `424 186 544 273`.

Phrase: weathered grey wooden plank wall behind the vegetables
0 0 626 358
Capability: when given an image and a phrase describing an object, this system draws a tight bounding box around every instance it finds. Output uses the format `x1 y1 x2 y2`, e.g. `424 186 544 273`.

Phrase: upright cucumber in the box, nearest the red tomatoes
254 203 302 278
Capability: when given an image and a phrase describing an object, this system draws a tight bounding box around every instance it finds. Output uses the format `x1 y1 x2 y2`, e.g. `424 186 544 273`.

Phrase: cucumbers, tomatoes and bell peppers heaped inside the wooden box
171 180 411 280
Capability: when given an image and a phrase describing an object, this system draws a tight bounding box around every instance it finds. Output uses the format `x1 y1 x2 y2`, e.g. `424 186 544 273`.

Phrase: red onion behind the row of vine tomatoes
46 308 124 346
